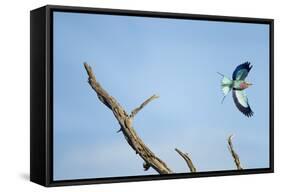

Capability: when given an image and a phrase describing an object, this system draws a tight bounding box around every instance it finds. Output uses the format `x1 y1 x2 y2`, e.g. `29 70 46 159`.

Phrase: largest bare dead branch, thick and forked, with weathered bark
84 63 172 174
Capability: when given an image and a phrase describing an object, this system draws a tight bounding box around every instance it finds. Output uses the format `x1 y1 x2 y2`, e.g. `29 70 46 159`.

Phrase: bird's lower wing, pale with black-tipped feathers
232 90 254 117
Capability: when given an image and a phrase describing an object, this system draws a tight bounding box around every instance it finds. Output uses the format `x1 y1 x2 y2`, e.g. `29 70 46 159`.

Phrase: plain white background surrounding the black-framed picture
0 0 276 192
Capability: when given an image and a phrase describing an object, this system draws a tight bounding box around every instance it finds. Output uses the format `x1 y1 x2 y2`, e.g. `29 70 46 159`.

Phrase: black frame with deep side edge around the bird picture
30 5 274 187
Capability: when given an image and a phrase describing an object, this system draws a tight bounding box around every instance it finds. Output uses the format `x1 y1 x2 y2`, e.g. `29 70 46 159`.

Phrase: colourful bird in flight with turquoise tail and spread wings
218 62 254 117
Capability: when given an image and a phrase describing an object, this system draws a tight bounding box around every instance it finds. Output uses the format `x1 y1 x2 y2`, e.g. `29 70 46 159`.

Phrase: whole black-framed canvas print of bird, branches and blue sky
30 5 274 186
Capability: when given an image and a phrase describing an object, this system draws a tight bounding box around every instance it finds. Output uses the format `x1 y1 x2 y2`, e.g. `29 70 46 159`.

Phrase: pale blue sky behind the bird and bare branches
54 12 269 180
